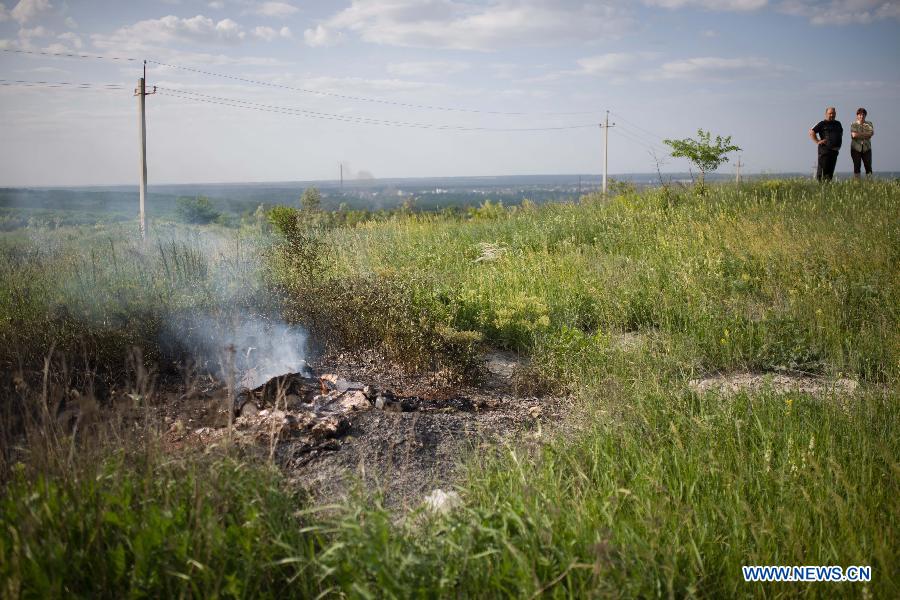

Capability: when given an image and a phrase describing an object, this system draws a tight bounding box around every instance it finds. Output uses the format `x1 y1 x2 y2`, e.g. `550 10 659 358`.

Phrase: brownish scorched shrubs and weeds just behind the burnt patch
267 208 482 375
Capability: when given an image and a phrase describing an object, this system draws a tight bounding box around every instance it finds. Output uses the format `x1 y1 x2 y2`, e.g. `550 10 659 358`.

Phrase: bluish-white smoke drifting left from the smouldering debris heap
10 192 316 388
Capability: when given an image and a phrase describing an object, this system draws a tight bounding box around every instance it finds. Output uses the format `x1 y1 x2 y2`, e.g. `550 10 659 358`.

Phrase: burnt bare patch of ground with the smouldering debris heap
155 353 566 507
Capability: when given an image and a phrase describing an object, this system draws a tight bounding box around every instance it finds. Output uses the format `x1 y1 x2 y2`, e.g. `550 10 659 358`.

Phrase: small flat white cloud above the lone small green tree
643 56 791 82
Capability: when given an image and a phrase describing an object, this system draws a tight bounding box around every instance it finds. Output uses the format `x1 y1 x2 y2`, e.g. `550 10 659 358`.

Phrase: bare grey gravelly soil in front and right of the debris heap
276 354 565 508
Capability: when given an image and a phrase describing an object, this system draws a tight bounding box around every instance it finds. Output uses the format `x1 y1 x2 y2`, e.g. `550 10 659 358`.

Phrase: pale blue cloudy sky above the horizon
0 0 900 187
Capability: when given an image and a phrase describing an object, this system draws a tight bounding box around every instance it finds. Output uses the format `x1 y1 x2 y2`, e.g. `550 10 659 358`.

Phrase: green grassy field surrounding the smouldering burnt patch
0 181 900 598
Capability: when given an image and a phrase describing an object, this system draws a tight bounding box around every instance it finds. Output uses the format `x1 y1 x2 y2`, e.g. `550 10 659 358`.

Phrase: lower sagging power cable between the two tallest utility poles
156 86 597 132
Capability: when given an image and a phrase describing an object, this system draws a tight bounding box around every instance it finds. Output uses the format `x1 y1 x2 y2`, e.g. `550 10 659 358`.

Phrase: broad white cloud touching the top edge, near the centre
305 0 634 50
